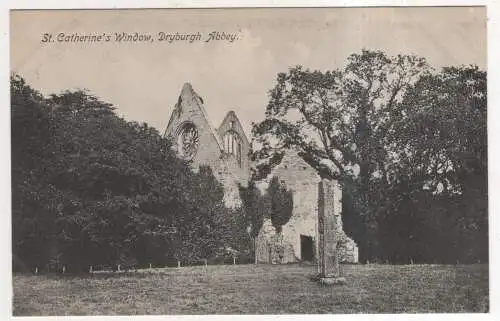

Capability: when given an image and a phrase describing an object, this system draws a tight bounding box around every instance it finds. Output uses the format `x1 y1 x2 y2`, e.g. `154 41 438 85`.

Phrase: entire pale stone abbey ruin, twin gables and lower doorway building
165 83 358 264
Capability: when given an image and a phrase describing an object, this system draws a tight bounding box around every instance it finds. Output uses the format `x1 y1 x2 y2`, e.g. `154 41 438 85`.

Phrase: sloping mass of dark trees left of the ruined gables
11 75 252 272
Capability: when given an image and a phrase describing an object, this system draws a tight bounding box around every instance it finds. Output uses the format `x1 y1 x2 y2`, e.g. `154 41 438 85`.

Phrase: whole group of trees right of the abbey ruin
253 50 488 263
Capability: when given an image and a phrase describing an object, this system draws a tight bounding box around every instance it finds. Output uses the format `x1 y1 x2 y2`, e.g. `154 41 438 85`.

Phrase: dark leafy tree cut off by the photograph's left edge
10 75 55 268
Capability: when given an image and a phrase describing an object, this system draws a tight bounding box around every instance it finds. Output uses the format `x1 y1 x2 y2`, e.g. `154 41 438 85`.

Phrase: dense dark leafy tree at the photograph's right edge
393 66 488 262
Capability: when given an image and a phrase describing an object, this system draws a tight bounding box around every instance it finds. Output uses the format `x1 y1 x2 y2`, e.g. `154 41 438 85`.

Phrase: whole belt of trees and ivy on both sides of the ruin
11 50 488 271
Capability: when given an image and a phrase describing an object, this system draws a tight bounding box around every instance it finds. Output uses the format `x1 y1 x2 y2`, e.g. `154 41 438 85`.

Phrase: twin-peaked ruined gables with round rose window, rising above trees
165 83 250 208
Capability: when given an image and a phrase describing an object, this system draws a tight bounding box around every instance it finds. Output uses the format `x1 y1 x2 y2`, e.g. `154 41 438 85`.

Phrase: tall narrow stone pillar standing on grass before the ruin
318 179 345 284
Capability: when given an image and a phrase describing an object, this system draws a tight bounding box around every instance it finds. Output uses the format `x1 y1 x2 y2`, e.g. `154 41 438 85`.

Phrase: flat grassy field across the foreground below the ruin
13 265 489 316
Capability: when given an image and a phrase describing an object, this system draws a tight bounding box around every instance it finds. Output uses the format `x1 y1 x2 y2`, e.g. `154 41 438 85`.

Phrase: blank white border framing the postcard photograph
0 0 500 320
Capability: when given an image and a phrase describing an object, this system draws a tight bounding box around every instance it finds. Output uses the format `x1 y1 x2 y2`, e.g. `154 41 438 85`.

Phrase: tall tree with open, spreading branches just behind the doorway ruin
252 50 428 260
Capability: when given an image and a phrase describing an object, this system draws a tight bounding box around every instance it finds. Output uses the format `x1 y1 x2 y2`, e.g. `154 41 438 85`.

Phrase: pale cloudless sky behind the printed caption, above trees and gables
10 7 487 135
